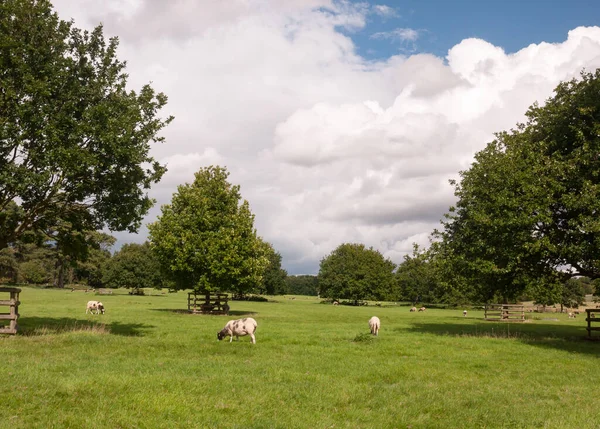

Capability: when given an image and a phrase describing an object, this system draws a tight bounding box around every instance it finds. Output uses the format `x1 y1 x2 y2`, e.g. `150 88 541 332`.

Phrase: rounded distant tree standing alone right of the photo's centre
319 243 396 303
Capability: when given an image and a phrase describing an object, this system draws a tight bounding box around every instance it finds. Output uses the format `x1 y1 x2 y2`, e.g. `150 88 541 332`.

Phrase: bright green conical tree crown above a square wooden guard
148 166 268 294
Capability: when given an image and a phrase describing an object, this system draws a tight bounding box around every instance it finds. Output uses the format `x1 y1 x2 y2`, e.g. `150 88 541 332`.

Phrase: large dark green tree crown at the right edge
436 70 600 300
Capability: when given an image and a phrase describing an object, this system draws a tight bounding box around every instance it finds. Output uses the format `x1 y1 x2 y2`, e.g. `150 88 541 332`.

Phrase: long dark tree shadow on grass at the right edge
399 317 600 356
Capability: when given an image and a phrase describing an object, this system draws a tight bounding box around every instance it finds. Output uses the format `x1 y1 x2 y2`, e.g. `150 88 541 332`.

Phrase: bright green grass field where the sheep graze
0 288 600 429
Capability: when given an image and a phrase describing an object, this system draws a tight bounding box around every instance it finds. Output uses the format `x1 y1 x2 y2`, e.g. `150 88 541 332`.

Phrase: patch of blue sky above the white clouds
346 0 600 59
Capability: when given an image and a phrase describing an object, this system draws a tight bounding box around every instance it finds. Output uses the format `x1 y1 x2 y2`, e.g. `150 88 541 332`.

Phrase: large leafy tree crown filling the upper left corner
0 0 172 248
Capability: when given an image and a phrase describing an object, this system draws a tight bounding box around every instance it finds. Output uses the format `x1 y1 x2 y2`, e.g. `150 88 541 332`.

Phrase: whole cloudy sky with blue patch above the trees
53 0 600 274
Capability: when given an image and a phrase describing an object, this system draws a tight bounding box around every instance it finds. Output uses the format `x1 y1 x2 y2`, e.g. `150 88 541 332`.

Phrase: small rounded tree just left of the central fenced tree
102 242 163 292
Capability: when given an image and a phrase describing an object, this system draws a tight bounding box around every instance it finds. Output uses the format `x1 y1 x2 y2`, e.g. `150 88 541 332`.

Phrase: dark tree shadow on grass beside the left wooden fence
18 317 154 337
